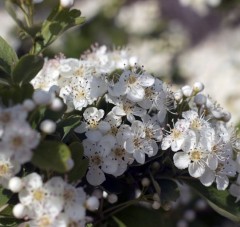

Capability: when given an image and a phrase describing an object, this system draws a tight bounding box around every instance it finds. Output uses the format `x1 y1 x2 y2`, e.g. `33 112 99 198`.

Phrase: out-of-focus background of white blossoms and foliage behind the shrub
0 0 240 227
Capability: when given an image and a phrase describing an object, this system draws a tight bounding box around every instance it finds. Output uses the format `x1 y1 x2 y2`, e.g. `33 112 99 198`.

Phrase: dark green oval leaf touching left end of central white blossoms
12 55 44 84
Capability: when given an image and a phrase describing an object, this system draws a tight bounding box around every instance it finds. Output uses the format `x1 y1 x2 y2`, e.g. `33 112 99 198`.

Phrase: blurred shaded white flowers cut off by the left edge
0 102 40 188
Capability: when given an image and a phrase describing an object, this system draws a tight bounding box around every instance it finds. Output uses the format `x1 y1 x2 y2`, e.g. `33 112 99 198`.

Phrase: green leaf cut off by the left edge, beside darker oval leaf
0 36 18 76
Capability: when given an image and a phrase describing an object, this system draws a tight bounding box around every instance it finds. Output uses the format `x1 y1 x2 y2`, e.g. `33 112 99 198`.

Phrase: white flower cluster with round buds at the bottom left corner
9 172 99 227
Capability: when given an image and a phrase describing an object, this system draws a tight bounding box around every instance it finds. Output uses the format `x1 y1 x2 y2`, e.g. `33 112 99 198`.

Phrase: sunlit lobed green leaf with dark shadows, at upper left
35 5 85 53
